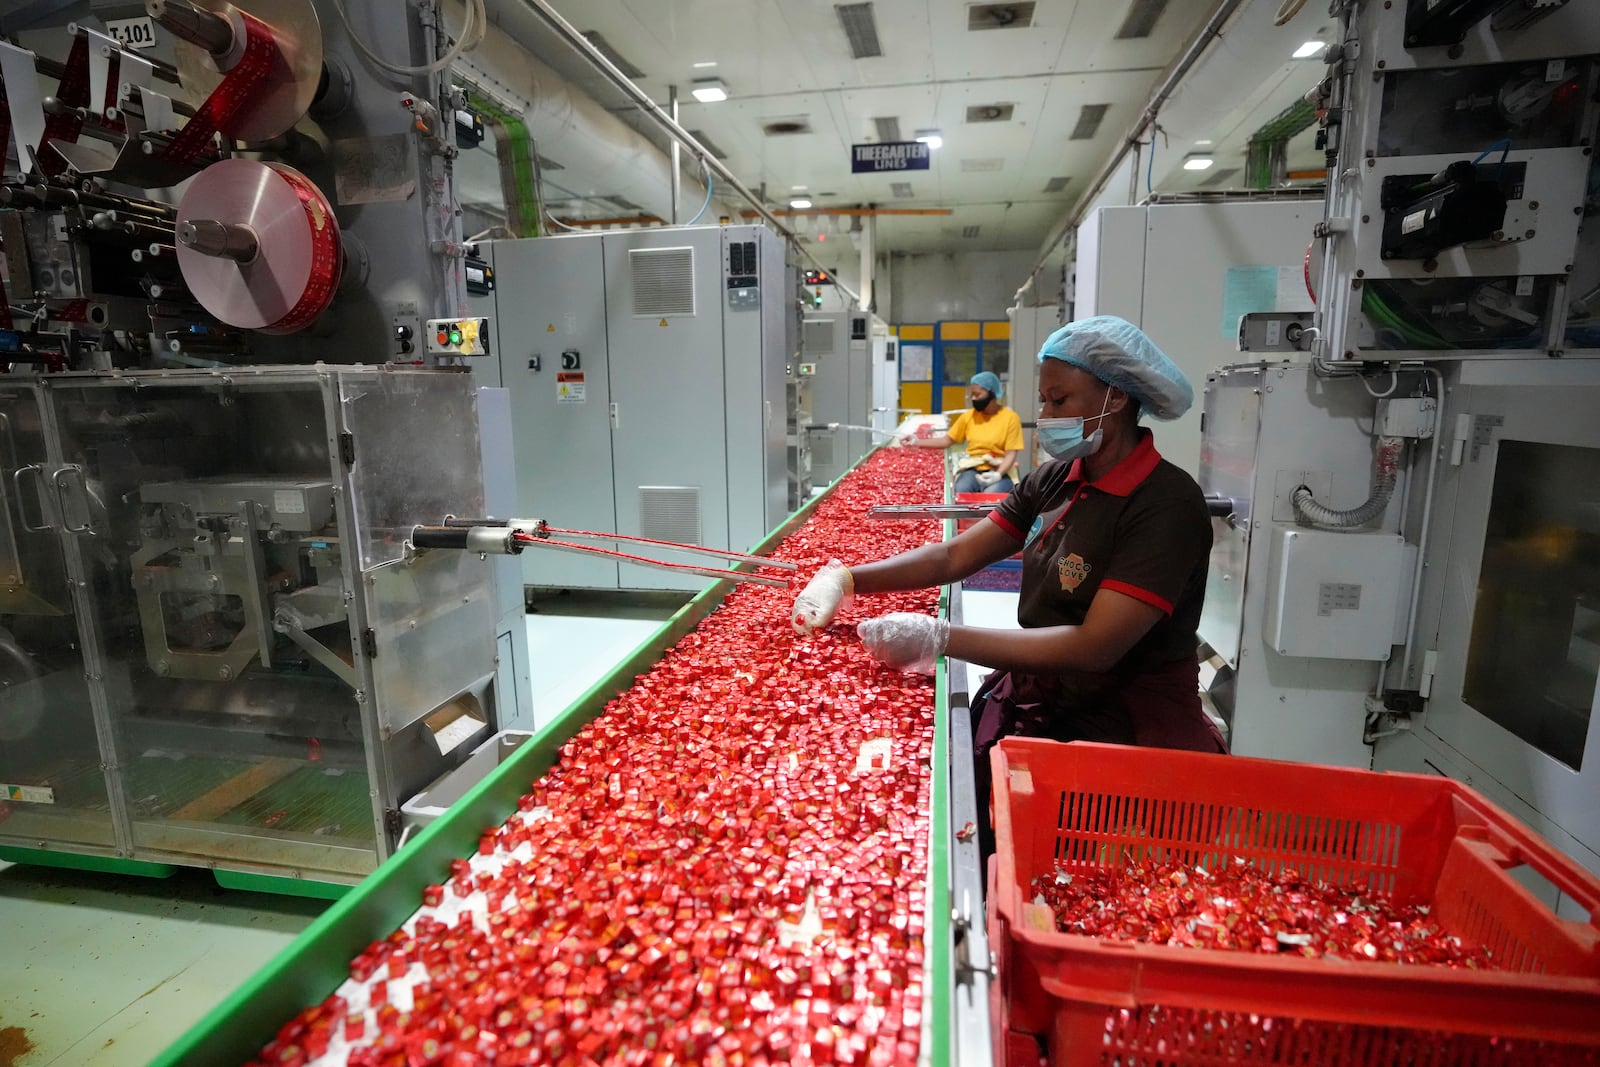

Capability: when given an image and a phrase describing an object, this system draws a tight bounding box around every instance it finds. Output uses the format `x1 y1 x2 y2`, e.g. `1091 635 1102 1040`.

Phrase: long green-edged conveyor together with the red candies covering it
157 450 990 1067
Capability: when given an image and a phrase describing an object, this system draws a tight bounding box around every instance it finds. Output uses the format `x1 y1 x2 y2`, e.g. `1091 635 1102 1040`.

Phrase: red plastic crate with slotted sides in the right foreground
989 739 1600 1067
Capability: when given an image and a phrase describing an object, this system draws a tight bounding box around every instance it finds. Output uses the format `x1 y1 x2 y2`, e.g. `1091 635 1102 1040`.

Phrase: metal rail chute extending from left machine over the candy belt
411 515 800 589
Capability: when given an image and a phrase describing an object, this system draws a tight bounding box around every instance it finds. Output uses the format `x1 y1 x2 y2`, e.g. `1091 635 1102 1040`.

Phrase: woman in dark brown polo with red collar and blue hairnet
794 315 1226 844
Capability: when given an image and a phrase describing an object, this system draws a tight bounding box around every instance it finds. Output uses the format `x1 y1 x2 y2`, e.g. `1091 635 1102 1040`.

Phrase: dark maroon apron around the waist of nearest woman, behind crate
973 657 1227 862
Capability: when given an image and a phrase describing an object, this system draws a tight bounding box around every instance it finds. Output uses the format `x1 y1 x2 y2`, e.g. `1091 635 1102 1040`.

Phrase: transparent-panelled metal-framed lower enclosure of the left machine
0 366 514 883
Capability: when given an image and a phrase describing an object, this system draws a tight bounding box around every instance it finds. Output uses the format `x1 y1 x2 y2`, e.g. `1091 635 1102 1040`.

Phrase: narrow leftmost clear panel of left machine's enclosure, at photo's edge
0 386 115 846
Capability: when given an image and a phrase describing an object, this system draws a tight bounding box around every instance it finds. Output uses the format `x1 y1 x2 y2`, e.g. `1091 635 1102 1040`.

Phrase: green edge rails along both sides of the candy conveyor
150 453 950 1067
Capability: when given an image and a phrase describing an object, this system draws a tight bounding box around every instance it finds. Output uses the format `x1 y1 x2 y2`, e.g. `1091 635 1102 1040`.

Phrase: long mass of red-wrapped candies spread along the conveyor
259 450 942 1067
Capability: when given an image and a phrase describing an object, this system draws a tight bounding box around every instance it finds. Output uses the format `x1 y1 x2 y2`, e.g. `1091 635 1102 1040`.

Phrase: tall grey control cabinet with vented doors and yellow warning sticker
486 226 789 589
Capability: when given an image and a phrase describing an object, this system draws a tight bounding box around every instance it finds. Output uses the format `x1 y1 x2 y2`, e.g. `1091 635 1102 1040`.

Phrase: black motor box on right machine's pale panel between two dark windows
1379 160 1504 259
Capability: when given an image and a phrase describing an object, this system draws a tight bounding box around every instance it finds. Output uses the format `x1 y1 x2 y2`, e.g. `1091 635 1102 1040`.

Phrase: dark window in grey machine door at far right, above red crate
1462 442 1600 769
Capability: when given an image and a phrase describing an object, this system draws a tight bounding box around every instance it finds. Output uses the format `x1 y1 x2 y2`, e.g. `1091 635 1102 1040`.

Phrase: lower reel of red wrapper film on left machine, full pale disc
176 160 344 333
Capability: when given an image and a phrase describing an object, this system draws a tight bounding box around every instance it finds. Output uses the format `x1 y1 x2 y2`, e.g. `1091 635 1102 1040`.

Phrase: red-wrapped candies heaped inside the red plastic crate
1032 859 1494 968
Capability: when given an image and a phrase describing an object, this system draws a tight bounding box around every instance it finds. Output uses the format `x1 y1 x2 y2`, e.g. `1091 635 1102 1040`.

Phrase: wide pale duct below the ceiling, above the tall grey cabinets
445 3 706 219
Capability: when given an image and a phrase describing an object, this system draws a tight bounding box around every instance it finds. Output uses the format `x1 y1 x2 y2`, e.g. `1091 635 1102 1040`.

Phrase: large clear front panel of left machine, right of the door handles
42 373 376 877
